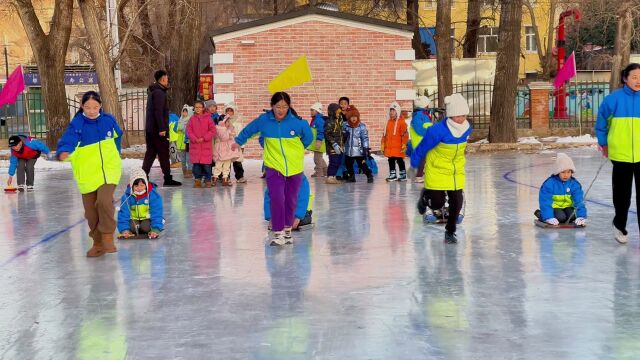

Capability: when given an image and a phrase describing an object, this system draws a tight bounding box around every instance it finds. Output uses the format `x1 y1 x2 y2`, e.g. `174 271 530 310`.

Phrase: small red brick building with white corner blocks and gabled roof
211 7 415 157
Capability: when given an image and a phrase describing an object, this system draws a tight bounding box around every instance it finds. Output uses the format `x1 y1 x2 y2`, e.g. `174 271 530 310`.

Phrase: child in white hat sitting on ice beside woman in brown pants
118 169 164 239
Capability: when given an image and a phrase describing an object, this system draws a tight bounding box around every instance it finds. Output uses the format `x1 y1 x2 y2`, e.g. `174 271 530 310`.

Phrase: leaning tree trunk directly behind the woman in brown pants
78 0 129 148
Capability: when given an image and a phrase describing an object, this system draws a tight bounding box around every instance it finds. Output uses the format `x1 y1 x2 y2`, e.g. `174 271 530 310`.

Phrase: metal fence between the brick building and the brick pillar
419 82 531 129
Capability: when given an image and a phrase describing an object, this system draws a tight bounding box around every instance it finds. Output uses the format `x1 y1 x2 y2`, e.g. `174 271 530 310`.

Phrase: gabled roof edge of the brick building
209 6 413 41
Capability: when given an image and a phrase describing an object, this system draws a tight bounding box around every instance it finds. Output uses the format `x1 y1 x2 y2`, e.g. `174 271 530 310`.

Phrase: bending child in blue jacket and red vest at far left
7 135 49 191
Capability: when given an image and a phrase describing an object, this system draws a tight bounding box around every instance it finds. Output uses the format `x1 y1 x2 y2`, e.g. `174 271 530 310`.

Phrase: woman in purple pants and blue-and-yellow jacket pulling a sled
232 92 313 245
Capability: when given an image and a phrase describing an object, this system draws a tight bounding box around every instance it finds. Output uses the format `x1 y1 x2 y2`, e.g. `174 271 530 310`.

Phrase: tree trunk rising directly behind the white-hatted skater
435 0 453 107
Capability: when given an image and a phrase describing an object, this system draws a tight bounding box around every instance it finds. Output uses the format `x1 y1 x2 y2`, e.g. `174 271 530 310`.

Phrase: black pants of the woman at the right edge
611 160 640 235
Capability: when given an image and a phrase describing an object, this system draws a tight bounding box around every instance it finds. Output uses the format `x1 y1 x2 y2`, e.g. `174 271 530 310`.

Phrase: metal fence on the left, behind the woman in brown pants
0 87 147 139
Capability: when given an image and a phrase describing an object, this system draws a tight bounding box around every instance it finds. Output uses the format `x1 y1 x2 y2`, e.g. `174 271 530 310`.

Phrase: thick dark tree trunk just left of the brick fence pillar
489 0 522 143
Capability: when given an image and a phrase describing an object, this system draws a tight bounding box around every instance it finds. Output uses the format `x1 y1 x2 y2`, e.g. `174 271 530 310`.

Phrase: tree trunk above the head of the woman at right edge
609 0 633 91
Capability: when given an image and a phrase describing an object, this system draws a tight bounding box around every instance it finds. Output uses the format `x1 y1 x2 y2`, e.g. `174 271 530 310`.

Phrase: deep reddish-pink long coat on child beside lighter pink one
187 113 216 164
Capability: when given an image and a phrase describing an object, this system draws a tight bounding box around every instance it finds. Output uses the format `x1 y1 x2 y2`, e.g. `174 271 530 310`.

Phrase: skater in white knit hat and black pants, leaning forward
411 93 471 244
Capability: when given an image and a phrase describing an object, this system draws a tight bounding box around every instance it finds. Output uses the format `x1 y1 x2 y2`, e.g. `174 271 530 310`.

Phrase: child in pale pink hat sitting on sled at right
535 153 587 226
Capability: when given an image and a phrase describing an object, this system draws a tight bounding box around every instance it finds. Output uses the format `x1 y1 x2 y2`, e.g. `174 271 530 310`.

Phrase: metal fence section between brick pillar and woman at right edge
549 81 609 128
